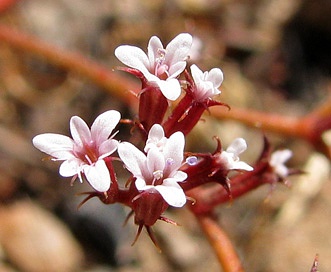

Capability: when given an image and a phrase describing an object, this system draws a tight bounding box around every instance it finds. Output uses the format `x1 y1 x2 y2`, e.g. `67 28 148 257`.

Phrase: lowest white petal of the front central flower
154 179 186 207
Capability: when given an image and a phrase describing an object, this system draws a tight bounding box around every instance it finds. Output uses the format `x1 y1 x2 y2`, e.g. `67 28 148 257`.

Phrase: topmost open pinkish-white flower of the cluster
115 33 192 100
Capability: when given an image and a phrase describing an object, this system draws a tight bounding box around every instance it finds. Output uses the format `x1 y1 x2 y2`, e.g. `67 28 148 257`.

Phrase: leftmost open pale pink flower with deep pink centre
32 110 121 192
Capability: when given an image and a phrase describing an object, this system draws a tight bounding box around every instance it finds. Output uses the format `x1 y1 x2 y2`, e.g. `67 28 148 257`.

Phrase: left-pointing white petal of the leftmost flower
32 133 75 160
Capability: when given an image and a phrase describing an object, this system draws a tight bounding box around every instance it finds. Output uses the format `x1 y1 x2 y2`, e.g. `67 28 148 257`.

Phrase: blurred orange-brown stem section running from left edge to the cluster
0 25 139 110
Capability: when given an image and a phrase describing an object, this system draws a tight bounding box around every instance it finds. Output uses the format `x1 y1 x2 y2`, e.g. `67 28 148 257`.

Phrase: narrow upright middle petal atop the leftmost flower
70 116 92 147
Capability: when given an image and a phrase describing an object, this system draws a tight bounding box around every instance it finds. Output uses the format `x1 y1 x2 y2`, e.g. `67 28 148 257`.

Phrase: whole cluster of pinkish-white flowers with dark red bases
33 33 291 246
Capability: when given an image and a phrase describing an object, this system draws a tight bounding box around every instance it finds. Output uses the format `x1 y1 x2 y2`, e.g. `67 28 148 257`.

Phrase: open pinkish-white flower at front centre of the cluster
118 124 187 207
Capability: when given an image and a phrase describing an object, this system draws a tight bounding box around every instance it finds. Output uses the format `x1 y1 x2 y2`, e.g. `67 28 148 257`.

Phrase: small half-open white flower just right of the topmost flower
191 64 223 101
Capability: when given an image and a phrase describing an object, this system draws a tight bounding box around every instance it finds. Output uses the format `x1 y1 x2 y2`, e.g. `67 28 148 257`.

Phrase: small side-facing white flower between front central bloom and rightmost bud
219 138 253 171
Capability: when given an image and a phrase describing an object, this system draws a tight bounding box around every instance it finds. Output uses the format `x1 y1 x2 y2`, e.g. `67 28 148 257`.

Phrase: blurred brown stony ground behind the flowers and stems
0 0 331 272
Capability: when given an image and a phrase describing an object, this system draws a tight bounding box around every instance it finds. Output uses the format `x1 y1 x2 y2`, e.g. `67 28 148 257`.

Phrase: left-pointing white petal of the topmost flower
115 45 150 77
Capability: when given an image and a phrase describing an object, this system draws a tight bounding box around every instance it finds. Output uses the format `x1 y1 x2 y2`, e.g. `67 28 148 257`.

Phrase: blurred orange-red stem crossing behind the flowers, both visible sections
0 25 331 159
